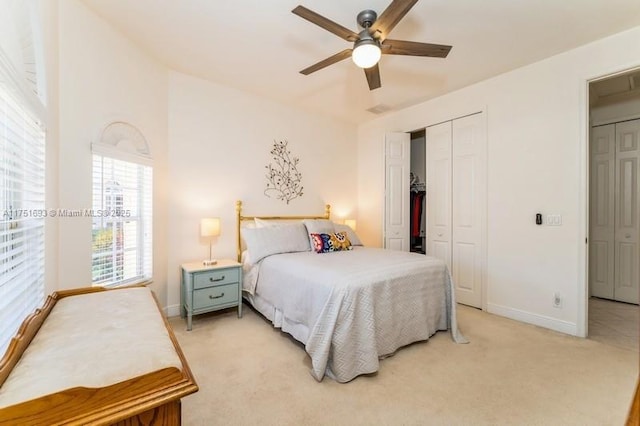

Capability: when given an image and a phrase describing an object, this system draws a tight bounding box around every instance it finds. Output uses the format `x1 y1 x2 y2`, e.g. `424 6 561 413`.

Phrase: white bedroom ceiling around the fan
84 0 640 123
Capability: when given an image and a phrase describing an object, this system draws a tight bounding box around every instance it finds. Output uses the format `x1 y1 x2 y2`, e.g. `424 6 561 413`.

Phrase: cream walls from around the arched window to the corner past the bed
52 0 357 314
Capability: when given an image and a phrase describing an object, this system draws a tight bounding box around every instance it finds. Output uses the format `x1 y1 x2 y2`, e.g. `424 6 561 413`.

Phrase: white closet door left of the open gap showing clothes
384 133 411 251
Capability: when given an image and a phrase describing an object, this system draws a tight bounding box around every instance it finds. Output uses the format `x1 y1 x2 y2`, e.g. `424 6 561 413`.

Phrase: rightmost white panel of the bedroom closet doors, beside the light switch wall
451 114 486 308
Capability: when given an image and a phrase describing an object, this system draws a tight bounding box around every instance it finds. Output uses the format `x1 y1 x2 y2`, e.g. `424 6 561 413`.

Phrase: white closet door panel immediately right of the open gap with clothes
425 121 452 271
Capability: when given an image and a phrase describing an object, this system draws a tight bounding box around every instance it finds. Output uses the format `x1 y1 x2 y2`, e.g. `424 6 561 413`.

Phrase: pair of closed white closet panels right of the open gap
425 113 486 308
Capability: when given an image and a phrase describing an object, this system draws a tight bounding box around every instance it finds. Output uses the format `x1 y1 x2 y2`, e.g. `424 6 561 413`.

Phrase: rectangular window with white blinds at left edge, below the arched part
0 78 46 357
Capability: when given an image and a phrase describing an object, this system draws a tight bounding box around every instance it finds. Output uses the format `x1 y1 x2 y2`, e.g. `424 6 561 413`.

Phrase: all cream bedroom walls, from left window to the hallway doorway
46 0 640 335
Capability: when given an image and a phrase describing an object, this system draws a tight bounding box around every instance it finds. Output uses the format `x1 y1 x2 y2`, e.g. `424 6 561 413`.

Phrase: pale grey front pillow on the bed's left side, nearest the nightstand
243 223 311 264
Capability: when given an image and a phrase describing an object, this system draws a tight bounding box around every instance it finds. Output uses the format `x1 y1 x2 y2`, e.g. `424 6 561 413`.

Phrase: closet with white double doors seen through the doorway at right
589 119 640 304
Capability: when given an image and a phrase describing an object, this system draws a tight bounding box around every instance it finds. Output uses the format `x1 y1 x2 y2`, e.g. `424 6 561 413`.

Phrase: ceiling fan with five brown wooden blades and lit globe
291 0 451 90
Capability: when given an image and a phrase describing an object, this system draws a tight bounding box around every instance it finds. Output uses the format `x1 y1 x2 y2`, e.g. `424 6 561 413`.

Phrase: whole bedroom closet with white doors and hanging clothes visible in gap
383 113 487 308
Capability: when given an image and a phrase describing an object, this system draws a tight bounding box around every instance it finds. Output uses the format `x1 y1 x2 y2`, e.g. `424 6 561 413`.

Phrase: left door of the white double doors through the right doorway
589 124 616 299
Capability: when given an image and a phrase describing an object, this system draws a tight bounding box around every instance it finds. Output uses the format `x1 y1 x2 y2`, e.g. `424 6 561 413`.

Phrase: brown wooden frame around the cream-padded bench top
0 284 198 426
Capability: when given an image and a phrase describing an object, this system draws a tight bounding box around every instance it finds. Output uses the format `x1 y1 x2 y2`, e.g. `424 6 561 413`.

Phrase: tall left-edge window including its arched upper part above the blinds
0 0 47 357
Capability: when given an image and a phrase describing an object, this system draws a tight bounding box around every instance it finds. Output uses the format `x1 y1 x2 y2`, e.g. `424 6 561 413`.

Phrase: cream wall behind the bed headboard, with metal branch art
168 72 357 314
